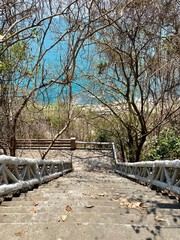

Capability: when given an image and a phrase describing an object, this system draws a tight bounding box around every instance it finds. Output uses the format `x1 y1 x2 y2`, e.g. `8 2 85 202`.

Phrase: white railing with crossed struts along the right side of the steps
116 160 180 196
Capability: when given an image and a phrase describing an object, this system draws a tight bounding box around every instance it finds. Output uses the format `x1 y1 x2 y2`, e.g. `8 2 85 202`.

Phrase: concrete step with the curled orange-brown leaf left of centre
0 201 180 217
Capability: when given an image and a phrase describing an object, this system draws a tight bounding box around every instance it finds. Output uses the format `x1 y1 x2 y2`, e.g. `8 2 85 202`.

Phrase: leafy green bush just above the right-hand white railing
143 128 180 160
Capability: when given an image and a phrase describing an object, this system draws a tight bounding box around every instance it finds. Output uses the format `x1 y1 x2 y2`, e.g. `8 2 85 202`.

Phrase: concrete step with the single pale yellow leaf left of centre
0 210 180 227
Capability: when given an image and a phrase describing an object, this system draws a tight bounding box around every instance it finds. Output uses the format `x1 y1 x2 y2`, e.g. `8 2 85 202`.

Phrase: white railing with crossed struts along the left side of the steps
0 155 72 196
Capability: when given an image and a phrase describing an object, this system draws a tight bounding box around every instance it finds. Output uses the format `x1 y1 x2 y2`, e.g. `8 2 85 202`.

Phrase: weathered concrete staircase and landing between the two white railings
0 152 180 240
